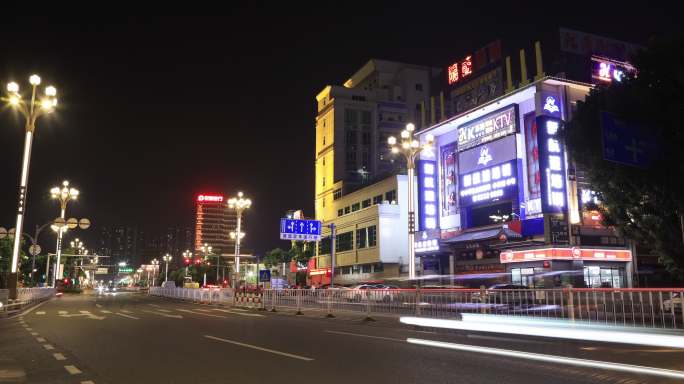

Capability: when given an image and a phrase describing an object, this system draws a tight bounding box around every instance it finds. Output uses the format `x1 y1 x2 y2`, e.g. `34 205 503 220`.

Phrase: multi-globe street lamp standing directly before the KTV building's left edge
387 123 434 279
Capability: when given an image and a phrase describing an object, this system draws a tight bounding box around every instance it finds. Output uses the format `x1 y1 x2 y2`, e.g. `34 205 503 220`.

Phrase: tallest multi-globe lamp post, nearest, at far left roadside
5 75 57 299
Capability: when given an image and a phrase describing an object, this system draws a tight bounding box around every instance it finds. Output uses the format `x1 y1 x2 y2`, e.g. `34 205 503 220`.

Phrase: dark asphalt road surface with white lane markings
0 293 684 384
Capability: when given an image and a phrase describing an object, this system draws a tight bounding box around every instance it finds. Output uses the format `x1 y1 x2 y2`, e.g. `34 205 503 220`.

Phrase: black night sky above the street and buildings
0 6 680 252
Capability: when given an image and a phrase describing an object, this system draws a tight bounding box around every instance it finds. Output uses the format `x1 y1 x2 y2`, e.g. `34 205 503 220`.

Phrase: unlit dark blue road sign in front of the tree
601 112 657 168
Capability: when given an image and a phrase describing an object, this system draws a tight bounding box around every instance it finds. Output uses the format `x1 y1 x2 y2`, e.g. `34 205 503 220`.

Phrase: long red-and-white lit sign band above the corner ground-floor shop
499 247 632 263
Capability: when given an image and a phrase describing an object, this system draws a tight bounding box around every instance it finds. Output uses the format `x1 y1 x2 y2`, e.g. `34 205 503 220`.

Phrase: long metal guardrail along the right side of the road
150 287 684 329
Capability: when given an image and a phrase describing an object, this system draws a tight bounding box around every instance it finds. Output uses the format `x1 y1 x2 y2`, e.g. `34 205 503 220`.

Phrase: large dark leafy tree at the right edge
564 36 684 279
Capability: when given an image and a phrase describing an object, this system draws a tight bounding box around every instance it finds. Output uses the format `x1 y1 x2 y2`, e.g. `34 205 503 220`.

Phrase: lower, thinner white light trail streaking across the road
406 338 684 379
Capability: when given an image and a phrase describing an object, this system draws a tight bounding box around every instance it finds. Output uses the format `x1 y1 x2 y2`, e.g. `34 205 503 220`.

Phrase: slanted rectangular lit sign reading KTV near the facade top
458 104 518 151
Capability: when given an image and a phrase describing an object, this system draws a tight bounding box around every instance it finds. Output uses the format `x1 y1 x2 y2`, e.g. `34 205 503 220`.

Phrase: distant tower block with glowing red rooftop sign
194 194 237 255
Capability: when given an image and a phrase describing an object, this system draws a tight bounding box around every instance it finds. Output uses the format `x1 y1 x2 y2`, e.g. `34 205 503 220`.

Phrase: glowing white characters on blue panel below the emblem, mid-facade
459 161 517 205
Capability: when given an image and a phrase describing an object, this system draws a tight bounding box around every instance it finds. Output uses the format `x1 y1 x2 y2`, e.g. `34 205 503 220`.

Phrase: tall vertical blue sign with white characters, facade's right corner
537 116 567 213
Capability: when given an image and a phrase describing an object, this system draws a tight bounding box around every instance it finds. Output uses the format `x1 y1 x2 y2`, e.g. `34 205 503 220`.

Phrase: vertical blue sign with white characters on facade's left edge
418 160 439 231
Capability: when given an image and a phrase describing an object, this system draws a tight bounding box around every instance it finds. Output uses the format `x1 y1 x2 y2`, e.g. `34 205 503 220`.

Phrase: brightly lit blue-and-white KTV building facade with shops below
415 77 633 288
